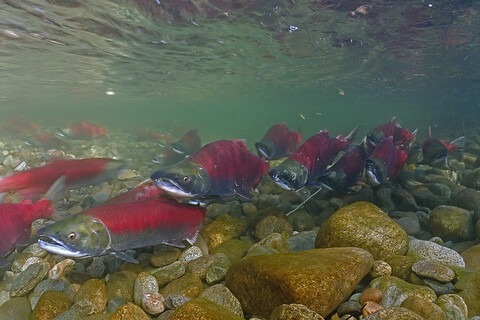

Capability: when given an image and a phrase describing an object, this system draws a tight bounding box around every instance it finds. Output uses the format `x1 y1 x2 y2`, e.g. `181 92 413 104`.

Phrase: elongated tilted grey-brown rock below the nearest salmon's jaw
10 258 48 297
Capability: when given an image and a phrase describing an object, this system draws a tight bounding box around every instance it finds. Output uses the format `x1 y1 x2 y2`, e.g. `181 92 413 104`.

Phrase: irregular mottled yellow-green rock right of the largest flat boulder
370 276 437 308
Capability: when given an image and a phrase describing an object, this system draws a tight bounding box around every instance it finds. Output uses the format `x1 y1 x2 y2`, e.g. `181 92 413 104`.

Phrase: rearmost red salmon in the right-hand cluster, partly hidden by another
364 117 418 153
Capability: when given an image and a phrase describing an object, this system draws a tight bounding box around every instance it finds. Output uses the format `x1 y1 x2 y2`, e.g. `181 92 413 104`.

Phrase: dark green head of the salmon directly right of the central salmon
269 159 308 190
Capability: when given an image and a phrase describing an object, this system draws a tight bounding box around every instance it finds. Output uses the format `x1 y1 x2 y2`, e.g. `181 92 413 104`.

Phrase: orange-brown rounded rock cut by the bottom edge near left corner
31 290 72 320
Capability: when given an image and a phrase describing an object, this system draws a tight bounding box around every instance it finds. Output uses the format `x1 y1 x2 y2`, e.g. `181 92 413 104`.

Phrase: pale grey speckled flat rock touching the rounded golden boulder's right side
408 238 465 268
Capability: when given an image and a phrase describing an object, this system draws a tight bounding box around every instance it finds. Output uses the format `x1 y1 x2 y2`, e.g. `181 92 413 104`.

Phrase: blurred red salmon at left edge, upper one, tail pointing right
0 158 126 198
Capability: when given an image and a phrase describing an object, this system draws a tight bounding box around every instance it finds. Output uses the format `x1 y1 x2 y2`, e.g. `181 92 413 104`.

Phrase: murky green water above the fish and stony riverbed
0 0 480 141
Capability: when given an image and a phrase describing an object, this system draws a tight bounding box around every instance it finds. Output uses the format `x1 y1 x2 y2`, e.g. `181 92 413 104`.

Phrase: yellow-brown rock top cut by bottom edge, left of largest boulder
168 298 243 320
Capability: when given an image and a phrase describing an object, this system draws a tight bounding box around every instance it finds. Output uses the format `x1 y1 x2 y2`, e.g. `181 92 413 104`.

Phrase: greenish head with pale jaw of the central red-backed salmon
151 160 211 198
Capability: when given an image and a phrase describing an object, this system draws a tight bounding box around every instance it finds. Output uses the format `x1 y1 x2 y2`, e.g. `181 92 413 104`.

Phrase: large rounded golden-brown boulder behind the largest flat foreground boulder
315 201 408 260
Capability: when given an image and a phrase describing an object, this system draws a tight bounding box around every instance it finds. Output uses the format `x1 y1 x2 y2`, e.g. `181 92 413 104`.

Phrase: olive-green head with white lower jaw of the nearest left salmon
37 214 111 258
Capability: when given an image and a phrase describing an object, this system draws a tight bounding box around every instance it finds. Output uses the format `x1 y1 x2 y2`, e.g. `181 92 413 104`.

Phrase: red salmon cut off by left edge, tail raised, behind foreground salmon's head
0 177 65 267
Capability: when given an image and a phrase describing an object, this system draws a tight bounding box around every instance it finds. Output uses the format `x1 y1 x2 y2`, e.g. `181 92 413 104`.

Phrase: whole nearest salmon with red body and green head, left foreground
37 195 205 263
